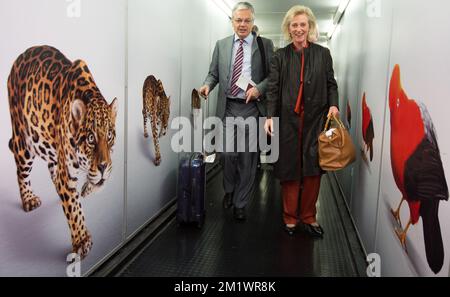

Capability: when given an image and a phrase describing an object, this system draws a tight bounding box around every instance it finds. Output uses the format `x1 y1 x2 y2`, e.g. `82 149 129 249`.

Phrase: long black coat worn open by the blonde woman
266 43 339 181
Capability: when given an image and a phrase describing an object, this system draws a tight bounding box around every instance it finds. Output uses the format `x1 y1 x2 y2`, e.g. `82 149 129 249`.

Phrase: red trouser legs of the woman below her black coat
281 175 321 225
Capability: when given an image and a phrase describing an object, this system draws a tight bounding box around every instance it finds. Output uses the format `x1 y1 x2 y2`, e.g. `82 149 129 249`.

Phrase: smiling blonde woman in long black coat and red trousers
264 5 339 237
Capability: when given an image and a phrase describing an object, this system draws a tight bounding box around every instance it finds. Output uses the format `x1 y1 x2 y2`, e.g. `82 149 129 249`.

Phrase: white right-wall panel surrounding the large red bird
377 0 450 276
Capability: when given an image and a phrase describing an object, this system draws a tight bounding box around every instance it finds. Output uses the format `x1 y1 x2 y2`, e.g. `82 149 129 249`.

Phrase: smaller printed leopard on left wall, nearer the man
142 75 170 166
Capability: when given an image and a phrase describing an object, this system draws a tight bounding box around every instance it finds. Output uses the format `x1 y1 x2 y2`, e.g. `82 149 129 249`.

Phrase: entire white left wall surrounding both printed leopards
0 0 231 276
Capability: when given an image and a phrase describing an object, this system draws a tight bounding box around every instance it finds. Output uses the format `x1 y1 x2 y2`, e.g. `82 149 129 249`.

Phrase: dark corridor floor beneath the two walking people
119 170 365 277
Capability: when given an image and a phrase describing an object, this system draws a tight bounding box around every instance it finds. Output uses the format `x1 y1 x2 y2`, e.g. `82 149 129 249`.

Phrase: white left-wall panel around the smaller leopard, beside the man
127 0 231 236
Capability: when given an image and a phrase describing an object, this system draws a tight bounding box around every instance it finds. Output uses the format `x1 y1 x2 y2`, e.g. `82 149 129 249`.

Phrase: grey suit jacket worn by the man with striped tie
203 34 273 119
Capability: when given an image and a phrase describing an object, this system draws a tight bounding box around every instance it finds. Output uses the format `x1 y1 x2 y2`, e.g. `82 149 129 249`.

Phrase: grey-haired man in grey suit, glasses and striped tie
199 2 273 220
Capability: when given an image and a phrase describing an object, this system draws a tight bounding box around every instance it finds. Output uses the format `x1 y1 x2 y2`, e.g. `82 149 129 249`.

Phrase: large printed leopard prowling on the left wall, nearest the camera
8 46 117 258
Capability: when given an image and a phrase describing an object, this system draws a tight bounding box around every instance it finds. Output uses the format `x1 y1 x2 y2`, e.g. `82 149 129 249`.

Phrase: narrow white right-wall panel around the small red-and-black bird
352 1 392 253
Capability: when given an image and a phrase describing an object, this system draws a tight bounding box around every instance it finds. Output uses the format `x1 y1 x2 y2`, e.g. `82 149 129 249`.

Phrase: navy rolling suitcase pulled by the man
177 153 206 228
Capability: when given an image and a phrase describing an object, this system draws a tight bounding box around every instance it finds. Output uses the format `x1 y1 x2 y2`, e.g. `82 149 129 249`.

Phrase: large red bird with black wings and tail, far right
389 65 448 273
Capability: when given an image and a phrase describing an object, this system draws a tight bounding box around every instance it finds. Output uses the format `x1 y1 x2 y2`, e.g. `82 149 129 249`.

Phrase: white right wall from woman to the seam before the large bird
332 1 392 252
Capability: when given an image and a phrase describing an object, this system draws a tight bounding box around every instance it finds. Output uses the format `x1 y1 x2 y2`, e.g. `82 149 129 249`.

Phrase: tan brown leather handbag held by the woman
319 116 356 171
